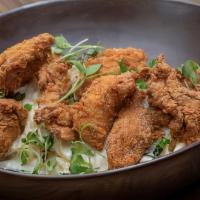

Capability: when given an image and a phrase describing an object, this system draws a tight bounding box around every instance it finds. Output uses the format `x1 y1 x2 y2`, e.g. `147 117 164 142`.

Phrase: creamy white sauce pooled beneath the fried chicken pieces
0 76 185 174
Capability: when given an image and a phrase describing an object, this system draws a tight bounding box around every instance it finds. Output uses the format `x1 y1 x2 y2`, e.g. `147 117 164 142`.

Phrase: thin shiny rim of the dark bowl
0 0 200 180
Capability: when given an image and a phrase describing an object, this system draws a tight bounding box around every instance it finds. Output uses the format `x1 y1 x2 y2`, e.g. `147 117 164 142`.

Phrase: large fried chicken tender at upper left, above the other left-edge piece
0 33 54 92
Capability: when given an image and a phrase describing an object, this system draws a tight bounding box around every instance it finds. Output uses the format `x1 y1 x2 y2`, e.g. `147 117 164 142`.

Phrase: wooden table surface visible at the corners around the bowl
0 0 200 200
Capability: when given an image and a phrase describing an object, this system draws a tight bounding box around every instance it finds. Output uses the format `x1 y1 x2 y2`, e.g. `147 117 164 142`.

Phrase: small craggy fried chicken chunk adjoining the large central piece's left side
34 103 77 141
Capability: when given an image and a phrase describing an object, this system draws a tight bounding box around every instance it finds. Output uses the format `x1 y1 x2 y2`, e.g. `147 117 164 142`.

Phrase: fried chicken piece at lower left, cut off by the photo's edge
0 99 28 160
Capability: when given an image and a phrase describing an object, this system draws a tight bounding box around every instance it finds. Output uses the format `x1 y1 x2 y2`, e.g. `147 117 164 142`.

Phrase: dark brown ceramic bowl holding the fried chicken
0 0 200 200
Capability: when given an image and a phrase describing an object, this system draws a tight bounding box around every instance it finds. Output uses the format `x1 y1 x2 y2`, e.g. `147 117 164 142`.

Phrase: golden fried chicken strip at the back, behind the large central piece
77 48 147 97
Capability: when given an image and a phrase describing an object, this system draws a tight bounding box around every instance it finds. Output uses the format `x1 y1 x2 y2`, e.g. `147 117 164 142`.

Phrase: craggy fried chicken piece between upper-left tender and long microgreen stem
38 57 70 105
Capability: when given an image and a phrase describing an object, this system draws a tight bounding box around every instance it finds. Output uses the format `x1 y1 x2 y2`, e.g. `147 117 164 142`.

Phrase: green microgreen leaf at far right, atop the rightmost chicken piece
177 60 200 85
